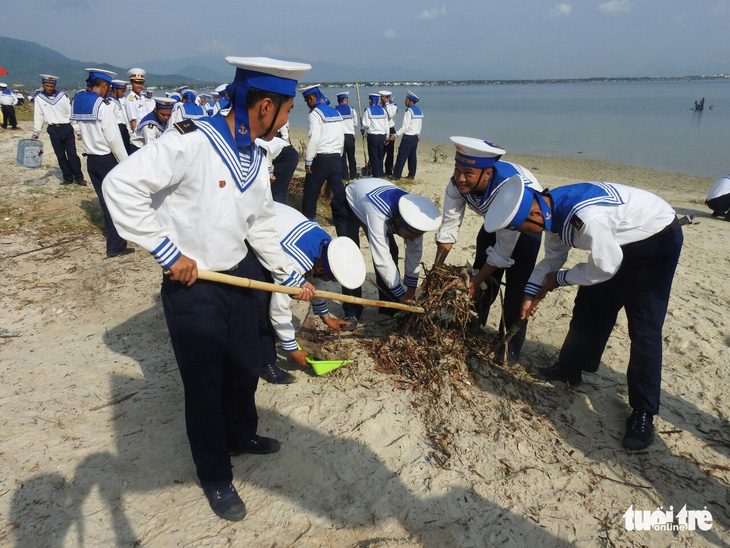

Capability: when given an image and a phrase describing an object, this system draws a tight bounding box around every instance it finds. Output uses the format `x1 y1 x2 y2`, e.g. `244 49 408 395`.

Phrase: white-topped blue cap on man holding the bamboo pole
226 57 312 97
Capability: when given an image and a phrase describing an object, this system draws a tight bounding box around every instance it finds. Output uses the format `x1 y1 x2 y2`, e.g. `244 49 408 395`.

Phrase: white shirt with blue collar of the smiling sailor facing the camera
436 161 542 268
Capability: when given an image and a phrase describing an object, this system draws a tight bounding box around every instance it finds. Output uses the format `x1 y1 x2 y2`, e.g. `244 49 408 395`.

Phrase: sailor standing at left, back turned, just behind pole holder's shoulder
70 68 134 257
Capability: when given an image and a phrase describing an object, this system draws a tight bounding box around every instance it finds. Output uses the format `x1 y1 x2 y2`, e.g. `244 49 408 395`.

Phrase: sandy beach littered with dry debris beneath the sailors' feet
0 122 730 548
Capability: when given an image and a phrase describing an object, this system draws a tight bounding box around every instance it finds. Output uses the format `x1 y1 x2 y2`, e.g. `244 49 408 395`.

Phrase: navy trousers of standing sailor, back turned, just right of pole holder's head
302 154 347 236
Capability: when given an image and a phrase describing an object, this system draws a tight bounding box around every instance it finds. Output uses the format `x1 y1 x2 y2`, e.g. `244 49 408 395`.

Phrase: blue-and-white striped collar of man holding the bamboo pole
195 114 264 192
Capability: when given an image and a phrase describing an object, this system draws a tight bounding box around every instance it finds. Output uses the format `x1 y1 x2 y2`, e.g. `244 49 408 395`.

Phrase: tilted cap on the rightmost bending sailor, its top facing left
484 174 552 232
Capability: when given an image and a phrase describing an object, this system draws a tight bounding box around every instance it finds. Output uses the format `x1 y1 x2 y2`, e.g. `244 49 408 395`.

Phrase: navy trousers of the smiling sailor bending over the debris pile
474 227 541 358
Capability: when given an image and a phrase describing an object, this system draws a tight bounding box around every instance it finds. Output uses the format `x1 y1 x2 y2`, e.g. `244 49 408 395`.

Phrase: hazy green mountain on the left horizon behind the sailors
0 36 220 91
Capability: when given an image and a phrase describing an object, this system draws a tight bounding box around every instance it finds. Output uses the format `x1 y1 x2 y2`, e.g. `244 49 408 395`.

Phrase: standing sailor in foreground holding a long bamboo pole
104 57 315 520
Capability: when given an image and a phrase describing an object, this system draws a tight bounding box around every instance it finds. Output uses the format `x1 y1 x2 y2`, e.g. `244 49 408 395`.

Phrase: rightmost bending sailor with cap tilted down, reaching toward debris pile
484 178 684 450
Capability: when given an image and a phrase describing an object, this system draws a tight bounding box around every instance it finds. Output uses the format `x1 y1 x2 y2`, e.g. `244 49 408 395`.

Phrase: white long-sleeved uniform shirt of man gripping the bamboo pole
102 117 304 287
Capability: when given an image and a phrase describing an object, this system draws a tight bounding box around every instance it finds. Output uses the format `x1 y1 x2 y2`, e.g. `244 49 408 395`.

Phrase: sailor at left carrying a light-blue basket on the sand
31 74 86 186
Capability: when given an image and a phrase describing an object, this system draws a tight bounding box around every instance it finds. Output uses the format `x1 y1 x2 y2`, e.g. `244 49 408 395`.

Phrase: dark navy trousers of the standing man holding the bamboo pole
161 260 261 487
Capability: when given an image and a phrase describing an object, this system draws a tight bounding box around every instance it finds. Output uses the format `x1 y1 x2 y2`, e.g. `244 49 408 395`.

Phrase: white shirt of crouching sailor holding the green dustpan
269 202 329 352
